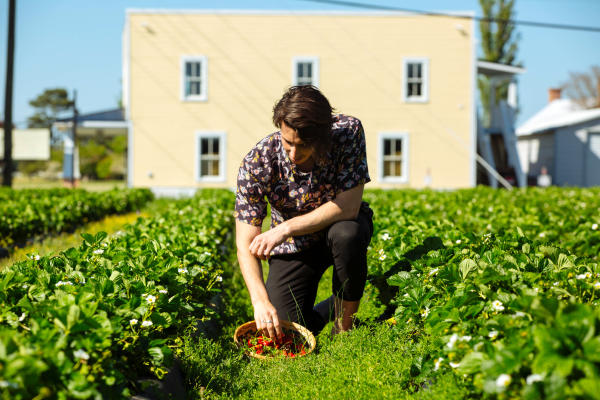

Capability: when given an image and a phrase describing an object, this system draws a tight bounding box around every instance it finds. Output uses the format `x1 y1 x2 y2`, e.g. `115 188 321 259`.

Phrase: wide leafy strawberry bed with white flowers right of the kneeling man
367 188 600 399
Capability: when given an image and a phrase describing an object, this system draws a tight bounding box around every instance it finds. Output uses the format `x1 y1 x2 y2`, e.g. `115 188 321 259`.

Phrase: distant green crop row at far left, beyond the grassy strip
0 188 153 247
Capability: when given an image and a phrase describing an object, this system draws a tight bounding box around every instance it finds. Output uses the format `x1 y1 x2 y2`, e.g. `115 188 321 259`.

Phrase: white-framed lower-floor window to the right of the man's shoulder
379 132 408 183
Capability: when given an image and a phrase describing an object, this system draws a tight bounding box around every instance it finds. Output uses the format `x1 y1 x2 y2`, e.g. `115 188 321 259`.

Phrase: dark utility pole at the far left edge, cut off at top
2 0 16 187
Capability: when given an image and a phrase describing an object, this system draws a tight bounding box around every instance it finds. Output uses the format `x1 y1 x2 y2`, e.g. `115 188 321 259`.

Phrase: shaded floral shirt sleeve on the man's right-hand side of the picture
336 119 371 194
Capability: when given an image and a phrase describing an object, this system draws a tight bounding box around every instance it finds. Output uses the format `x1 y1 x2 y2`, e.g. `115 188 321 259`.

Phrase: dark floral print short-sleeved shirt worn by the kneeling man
235 114 371 255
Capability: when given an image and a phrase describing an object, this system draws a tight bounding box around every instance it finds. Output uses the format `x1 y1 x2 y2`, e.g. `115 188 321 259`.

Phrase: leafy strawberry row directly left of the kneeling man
0 191 233 399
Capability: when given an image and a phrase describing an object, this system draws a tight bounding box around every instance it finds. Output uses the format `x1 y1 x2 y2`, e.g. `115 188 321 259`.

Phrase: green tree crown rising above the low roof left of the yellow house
27 88 73 129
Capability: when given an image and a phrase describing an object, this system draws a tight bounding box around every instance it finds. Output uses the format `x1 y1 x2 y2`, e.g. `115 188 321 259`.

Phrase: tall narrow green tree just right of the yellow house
477 0 520 125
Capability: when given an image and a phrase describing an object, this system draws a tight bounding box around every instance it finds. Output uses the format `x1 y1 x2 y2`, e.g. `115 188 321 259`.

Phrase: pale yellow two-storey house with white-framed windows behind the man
123 10 477 194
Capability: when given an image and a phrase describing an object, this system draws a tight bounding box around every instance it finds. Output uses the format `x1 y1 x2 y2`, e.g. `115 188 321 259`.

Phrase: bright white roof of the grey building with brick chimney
517 99 600 136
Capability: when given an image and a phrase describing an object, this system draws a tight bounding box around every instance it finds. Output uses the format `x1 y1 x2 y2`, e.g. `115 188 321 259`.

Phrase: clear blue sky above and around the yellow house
0 0 600 127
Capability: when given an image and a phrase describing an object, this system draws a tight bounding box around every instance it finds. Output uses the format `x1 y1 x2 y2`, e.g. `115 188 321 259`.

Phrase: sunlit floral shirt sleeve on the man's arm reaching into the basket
234 150 267 226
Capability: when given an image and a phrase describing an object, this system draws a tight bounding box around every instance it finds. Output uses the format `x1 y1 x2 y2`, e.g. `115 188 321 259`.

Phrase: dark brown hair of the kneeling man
273 85 333 160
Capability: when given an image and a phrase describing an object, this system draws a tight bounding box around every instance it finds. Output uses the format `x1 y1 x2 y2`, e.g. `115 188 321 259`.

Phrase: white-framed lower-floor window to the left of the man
196 132 227 182
